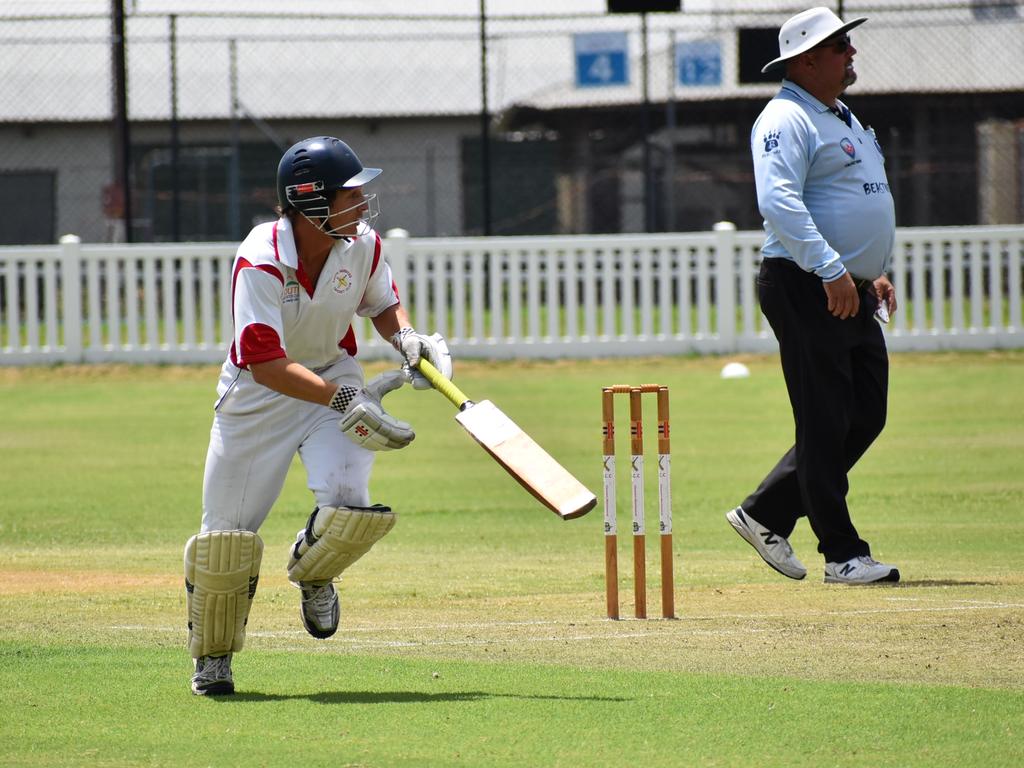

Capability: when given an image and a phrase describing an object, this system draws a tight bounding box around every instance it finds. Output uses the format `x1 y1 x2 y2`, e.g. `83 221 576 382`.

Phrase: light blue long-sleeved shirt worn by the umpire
751 80 896 283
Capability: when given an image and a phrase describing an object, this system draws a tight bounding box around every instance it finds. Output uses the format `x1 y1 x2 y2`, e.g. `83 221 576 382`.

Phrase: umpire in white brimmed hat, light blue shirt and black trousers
726 8 899 584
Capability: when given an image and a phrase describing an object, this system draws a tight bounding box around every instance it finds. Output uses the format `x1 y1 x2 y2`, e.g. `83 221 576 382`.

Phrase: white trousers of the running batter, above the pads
202 357 374 532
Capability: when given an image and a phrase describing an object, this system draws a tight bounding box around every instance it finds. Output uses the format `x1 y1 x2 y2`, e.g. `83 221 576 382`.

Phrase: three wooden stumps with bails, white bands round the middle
601 384 676 618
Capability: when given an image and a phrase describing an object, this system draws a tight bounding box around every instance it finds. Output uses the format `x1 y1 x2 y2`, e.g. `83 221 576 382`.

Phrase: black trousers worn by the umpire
742 258 889 562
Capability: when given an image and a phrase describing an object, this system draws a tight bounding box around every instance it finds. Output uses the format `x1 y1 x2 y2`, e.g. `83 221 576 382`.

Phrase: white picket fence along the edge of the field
0 225 1024 365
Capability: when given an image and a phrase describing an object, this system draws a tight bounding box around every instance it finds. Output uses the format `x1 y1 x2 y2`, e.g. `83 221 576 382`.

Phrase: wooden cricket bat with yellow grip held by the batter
419 358 597 520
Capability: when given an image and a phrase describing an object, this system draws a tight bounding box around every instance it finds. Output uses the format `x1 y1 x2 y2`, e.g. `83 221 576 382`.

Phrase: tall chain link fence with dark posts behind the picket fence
0 0 1024 244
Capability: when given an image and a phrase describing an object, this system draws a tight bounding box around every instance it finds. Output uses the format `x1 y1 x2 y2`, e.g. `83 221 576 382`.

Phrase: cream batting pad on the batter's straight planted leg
185 530 263 658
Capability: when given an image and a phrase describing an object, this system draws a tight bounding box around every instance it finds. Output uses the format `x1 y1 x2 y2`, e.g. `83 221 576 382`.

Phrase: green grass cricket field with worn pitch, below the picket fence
0 351 1024 768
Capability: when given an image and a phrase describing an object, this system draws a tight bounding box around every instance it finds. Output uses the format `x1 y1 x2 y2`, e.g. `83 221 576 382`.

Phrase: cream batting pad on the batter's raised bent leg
288 504 395 582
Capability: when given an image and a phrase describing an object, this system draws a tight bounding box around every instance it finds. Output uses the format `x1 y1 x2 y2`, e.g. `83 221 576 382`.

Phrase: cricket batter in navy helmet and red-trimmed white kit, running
184 136 452 695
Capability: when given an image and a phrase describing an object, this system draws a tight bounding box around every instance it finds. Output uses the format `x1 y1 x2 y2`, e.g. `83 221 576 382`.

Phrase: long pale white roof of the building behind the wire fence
0 0 1024 122
